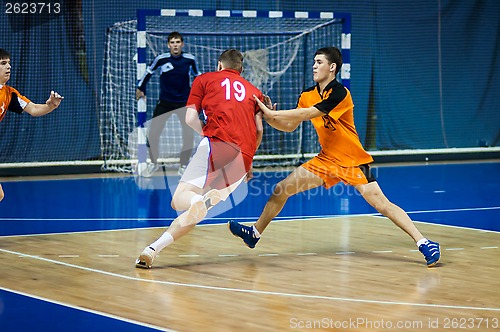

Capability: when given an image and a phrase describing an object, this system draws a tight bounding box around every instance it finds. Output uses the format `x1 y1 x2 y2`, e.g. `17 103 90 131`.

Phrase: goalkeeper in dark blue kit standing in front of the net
136 32 201 177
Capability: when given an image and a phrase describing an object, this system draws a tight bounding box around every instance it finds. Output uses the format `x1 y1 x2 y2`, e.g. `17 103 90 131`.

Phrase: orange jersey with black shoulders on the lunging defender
297 80 373 167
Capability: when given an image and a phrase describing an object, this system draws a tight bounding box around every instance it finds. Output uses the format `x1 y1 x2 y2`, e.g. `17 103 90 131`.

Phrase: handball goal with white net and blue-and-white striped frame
100 10 350 171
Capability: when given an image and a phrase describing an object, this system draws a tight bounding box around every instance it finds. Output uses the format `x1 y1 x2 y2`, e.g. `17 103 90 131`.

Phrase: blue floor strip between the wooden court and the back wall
0 162 500 236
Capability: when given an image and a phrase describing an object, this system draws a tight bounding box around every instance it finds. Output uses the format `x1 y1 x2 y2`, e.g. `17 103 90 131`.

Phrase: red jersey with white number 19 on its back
187 69 263 157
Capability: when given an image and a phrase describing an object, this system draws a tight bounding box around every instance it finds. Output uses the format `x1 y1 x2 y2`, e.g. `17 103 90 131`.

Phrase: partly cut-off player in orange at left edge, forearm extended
0 48 64 201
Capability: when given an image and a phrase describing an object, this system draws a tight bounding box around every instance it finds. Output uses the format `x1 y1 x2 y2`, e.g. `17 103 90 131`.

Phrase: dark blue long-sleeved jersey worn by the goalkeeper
137 53 201 103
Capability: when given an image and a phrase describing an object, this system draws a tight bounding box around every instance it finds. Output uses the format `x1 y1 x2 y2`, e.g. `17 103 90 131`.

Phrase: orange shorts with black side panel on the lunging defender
302 156 375 189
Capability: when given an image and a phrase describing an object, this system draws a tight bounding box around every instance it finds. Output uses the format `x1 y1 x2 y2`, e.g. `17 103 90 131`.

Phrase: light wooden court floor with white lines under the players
0 216 500 331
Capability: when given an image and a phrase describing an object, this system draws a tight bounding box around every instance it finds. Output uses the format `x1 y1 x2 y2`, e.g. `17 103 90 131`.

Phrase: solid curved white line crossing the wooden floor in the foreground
0 248 500 312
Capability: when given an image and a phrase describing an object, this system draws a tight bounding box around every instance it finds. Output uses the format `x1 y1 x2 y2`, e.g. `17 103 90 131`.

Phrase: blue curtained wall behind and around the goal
0 0 500 162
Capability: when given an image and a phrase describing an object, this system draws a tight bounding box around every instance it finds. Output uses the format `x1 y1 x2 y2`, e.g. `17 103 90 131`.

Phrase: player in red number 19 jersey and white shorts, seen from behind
136 49 267 268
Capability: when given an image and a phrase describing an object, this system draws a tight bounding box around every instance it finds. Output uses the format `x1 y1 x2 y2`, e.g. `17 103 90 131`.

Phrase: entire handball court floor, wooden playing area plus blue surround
0 160 500 331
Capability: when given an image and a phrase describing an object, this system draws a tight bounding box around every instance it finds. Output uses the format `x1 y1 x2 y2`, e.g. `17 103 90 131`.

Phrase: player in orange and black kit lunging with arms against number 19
229 47 440 267
